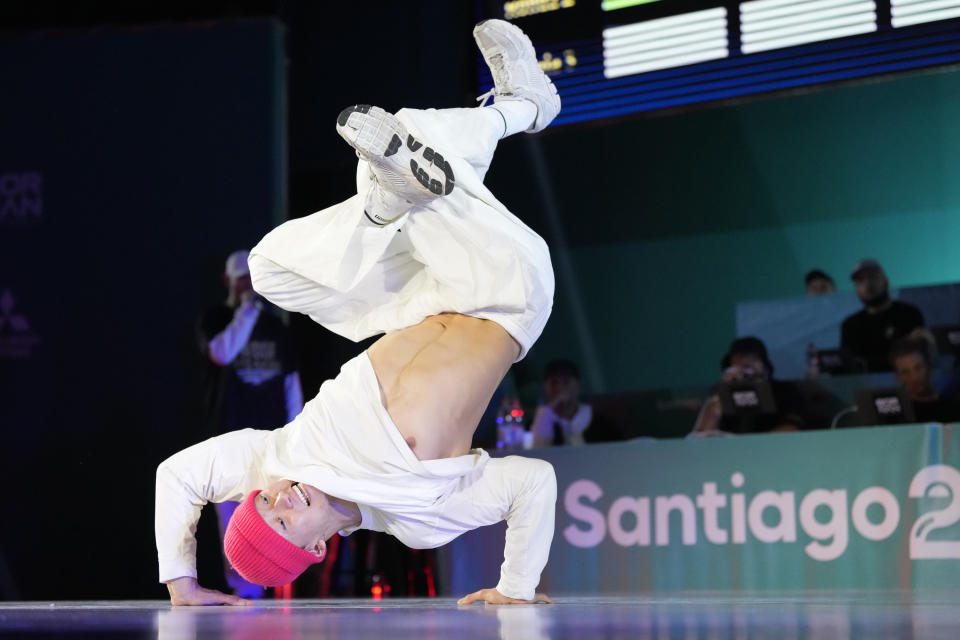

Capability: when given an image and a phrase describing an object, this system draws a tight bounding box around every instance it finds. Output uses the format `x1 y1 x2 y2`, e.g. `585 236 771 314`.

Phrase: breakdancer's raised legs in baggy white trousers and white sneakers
251 11 560 350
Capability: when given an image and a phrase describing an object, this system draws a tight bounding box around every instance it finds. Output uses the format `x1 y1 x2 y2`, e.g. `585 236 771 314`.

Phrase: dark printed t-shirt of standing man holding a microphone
197 304 296 434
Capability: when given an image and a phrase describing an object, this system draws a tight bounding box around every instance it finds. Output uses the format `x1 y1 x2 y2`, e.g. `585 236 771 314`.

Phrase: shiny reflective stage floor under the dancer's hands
0 591 960 640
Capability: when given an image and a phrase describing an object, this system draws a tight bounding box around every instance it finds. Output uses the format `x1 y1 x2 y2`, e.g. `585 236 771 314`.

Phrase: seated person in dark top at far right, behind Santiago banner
890 338 960 422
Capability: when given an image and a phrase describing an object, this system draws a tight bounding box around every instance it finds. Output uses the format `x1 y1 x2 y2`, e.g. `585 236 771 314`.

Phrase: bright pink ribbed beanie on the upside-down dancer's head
223 491 322 587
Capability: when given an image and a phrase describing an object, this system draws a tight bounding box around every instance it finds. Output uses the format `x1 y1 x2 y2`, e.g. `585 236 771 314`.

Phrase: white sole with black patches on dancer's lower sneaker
337 104 456 196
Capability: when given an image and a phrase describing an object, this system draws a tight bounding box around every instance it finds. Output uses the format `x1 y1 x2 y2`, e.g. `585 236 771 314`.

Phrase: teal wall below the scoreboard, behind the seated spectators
496 69 960 391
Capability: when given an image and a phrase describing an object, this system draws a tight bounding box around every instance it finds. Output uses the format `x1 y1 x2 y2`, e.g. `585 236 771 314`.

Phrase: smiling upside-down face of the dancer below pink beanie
255 480 330 557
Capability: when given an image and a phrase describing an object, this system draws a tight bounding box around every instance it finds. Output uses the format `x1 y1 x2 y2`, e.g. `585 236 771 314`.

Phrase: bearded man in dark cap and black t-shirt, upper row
840 258 924 371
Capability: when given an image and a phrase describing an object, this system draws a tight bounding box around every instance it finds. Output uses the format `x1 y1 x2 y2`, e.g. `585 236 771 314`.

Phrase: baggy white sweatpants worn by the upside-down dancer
249 109 554 359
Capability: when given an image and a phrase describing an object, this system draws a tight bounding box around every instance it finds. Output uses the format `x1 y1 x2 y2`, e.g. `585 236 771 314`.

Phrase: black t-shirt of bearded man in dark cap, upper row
840 300 923 371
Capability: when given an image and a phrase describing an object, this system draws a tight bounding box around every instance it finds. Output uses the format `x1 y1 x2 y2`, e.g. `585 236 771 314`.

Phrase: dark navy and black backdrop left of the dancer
0 2 488 599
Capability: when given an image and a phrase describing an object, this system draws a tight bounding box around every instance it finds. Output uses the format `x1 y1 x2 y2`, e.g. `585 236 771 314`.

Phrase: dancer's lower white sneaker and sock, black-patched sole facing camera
337 104 456 224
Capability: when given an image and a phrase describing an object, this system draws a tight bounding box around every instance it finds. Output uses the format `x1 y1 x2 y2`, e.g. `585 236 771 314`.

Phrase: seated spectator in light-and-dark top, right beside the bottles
530 360 623 447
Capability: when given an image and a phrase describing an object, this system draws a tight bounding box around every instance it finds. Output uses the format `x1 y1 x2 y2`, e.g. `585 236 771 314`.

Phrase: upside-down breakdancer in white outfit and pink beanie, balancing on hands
156 20 560 605
